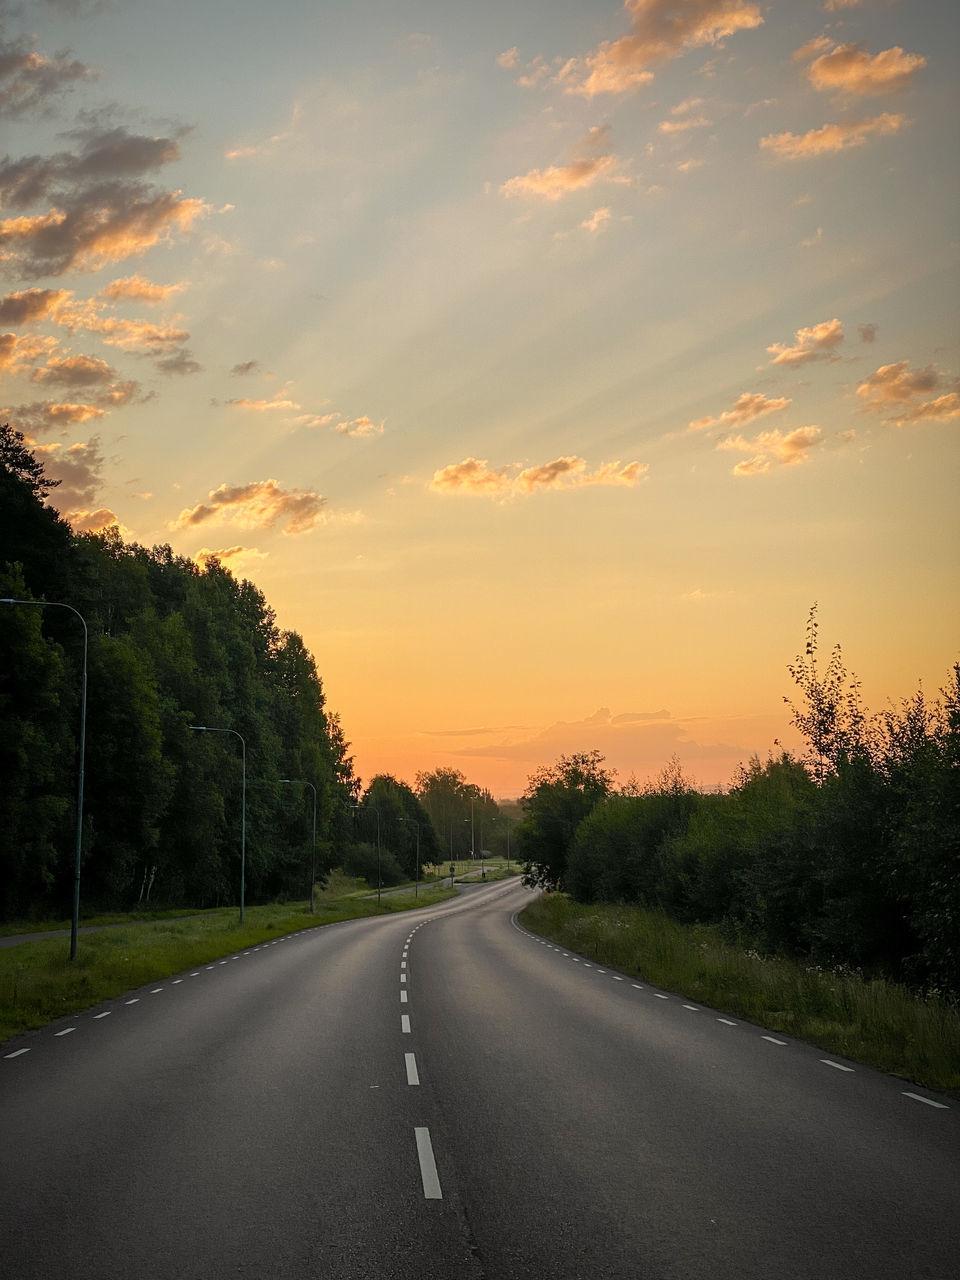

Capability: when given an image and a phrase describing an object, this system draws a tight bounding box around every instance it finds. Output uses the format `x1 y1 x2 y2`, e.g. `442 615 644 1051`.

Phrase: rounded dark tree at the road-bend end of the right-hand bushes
516 751 614 888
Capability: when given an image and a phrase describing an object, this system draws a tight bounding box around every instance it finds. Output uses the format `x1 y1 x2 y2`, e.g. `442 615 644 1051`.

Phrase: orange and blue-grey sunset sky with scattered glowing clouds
0 0 960 796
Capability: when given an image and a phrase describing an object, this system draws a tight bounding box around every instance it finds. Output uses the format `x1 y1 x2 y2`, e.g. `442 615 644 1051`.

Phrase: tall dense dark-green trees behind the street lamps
0 428 357 919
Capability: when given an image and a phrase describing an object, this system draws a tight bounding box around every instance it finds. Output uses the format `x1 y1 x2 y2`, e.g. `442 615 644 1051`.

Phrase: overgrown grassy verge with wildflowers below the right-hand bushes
520 893 960 1097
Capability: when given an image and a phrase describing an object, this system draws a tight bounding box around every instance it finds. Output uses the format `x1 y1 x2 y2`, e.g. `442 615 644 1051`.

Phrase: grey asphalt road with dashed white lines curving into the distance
0 882 960 1280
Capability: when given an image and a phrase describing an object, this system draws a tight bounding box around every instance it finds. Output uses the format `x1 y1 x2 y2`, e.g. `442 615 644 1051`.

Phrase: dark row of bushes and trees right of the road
517 611 960 997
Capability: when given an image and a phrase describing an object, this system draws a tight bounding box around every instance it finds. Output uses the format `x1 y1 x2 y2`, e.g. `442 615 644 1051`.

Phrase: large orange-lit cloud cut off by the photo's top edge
563 0 763 97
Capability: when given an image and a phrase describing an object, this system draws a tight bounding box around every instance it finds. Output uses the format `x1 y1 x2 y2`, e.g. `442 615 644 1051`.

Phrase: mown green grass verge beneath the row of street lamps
0 882 456 1042
